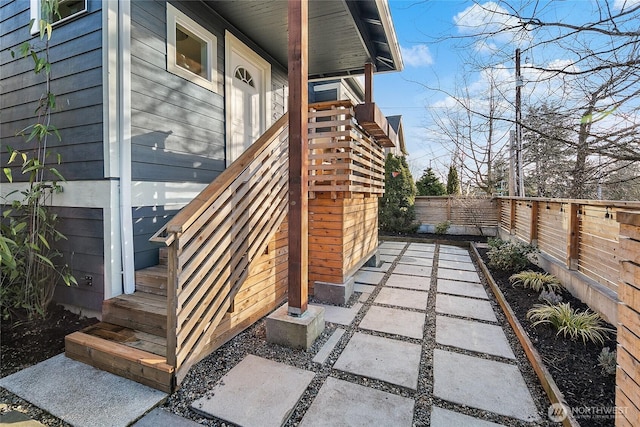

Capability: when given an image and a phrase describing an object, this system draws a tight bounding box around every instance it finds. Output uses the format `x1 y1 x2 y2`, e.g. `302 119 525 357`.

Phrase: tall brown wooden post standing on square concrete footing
288 0 309 316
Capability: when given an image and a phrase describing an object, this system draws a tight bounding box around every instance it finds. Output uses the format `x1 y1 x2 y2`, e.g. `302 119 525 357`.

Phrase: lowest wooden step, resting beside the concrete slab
65 322 174 393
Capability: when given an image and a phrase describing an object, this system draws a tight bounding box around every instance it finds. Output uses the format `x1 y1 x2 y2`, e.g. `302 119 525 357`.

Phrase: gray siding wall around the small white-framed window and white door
131 2 287 270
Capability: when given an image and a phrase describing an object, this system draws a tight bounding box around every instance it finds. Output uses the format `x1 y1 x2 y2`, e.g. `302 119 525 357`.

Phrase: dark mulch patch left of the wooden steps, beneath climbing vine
0 305 98 377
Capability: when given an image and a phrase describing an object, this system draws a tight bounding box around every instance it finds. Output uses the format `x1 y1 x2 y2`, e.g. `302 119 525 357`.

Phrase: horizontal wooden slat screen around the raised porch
309 101 385 198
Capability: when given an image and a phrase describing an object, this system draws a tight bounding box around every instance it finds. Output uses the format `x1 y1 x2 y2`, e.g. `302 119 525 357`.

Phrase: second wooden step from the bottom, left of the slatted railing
102 291 167 339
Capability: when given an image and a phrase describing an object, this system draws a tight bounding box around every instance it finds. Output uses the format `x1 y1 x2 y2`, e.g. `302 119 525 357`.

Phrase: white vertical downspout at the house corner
118 0 135 294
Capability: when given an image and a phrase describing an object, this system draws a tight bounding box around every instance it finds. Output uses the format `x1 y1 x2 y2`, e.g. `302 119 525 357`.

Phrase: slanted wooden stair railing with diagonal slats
150 114 289 383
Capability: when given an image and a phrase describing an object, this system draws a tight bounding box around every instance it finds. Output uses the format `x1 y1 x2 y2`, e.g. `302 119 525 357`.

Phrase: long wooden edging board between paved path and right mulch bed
470 244 580 427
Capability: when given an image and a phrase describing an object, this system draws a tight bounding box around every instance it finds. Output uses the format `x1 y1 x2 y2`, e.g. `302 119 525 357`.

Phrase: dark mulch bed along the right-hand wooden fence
478 248 616 426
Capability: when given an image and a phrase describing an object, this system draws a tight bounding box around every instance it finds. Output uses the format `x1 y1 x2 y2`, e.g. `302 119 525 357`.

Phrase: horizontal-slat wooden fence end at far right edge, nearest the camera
616 212 640 426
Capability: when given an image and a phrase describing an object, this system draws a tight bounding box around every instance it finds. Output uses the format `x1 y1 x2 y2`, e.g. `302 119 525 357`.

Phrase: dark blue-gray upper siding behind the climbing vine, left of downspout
0 0 104 181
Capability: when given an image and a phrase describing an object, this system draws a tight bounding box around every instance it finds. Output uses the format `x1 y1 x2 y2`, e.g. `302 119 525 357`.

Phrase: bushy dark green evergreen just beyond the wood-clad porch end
378 153 418 233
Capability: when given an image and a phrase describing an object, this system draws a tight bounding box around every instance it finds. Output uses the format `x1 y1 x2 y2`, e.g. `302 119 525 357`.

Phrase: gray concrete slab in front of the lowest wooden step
0 354 167 427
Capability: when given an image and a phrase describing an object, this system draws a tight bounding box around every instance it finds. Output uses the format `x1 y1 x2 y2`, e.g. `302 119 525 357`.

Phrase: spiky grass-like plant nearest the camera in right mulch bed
527 303 613 345
